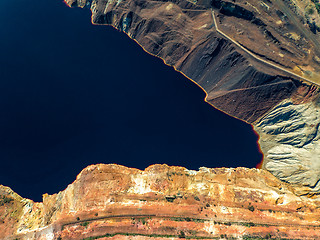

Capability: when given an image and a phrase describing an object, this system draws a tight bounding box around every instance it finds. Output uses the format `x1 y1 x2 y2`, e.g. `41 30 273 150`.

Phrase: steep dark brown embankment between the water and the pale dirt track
67 0 300 123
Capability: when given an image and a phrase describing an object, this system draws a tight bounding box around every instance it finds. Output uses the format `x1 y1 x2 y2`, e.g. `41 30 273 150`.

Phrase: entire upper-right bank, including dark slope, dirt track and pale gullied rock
61 0 320 195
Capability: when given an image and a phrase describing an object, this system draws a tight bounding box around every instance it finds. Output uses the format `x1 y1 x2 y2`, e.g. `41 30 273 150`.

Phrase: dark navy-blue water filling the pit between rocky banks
0 0 261 201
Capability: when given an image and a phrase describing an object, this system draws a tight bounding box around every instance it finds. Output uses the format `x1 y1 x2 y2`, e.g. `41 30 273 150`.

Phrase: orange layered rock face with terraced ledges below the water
0 164 320 239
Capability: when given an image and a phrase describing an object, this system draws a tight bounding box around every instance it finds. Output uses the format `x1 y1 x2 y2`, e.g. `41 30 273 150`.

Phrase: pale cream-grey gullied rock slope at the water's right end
255 86 320 194
